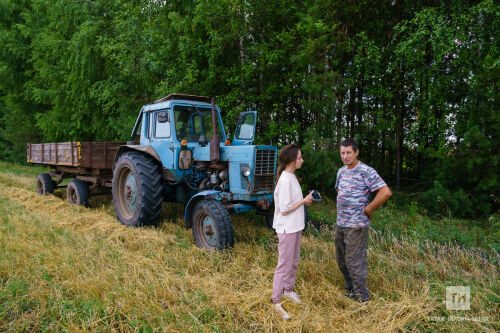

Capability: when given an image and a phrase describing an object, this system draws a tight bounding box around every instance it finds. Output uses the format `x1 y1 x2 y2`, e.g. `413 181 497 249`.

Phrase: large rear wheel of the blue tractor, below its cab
112 151 163 227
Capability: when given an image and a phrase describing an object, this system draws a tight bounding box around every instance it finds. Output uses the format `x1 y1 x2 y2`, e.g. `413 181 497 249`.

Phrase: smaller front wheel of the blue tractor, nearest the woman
191 199 234 250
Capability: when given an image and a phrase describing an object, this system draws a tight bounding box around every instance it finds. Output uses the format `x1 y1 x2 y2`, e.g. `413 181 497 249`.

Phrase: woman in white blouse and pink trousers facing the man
271 144 312 319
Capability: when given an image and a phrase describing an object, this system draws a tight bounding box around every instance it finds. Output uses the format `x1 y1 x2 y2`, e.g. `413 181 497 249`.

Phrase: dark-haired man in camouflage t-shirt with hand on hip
335 140 392 302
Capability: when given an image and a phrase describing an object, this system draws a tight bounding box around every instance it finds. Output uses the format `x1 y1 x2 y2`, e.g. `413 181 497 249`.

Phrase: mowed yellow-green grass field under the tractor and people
0 162 500 332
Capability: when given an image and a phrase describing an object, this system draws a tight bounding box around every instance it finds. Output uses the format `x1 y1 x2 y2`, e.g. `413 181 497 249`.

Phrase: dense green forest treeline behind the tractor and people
0 0 500 217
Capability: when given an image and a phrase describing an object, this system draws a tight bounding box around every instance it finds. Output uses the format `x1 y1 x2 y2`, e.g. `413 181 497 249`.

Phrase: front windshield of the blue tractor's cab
174 105 222 142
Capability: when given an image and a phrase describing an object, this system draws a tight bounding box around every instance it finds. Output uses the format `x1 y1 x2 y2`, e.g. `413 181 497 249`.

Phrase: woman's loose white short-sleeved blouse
273 171 305 234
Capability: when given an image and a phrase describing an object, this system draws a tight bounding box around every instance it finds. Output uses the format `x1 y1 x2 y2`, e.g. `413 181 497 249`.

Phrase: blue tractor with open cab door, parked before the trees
112 94 277 250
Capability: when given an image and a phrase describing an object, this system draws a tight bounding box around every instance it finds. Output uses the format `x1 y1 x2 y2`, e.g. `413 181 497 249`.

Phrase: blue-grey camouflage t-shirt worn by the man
335 161 386 228
